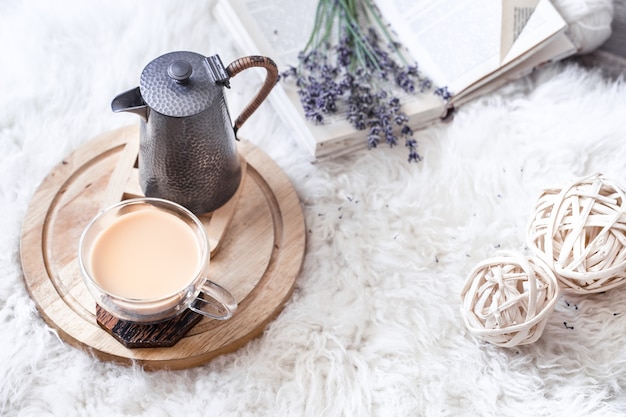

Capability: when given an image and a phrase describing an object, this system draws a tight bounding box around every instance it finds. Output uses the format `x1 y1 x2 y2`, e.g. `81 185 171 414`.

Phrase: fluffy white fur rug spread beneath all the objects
0 0 626 417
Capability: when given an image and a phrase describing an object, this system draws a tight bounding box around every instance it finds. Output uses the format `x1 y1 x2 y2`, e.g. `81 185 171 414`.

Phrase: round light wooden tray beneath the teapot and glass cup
20 127 305 370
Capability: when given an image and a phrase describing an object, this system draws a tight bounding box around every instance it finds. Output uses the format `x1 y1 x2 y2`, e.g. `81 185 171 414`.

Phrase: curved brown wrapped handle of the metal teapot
226 55 278 136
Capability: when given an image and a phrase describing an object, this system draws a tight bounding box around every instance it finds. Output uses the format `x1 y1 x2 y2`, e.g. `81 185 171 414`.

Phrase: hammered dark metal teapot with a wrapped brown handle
111 51 278 214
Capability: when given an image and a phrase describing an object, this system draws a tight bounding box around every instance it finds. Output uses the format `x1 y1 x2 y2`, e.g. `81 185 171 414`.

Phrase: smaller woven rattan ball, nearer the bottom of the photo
461 251 559 347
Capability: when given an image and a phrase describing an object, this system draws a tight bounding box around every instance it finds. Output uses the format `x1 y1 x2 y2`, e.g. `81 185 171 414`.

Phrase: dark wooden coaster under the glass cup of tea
96 303 202 349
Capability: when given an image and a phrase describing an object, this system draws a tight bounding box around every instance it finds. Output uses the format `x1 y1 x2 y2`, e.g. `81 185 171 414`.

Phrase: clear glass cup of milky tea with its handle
78 198 237 323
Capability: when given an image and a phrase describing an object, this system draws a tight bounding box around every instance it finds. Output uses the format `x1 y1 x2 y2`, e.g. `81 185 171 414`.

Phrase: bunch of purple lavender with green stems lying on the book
281 0 442 162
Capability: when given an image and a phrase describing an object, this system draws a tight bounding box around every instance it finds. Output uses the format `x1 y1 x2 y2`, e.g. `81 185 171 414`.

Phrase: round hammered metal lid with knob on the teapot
139 51 228 117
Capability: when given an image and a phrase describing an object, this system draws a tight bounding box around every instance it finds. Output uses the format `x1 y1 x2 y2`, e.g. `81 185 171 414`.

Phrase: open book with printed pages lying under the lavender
215 0 576 159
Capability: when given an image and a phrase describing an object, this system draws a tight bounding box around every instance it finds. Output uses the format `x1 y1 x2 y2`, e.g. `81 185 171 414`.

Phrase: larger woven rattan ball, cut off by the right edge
527 174 626 294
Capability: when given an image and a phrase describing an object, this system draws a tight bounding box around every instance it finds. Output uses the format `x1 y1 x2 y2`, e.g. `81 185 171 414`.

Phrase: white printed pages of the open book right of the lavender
377 0 566 95
